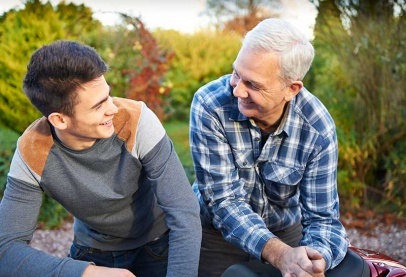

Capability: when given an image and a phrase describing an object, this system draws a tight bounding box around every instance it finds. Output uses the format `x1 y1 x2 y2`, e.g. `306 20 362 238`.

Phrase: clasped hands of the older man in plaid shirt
262 238 326 277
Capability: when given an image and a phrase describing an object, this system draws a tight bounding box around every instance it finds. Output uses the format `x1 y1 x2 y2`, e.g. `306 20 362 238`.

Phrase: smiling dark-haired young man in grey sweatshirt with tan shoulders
0 41 201 277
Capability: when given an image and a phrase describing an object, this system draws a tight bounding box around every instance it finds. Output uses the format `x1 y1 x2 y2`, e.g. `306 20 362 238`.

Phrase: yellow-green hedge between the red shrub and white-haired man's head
154 30 241 120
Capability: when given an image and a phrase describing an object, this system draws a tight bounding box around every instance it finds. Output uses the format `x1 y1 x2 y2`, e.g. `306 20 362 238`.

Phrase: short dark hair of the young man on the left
23 41 108 117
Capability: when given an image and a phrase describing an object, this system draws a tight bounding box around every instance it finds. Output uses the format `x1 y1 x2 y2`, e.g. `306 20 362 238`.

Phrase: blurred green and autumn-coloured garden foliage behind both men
0 0 406 228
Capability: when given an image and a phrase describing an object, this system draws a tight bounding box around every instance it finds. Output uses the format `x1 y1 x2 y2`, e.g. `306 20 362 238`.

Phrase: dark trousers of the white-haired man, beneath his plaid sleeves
199 223 302 277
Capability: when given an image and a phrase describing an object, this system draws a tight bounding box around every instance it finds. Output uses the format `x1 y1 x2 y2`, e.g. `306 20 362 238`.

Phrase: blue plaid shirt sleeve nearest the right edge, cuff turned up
300 131 348 269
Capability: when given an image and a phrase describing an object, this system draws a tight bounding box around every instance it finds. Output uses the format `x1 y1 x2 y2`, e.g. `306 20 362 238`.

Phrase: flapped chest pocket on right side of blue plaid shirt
262 162 303 208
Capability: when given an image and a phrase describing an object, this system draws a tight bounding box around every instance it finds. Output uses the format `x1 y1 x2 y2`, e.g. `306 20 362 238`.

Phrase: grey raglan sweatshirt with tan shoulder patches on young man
0 98 201 276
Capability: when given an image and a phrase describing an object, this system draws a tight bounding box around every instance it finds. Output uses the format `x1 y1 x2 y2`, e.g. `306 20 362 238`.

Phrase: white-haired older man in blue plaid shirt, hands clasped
190 19 348 276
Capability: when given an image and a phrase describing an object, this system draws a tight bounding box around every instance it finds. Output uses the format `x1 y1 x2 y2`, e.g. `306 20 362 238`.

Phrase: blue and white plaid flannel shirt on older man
190 75 348 269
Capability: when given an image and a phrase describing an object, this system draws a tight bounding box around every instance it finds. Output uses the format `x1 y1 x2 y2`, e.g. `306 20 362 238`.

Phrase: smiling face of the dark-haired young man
58 76 118 149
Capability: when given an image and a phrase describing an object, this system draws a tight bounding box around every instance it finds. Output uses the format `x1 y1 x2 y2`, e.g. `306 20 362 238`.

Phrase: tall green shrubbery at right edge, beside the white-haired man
315 0 406 211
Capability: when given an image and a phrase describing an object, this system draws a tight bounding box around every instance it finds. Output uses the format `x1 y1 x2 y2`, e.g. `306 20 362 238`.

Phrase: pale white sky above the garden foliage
0 0 317 38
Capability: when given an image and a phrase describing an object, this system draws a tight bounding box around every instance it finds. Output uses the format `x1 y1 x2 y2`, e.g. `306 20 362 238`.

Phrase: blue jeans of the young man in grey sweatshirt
69 232 169 277
